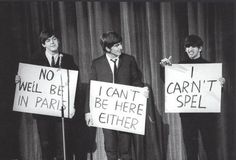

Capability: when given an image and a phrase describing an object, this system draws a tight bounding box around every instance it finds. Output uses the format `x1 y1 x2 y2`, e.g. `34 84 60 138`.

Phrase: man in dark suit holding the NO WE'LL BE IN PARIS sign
31 29 78 160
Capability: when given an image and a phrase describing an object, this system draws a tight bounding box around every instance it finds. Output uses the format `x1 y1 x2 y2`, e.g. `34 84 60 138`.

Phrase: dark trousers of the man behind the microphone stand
36 116 73 160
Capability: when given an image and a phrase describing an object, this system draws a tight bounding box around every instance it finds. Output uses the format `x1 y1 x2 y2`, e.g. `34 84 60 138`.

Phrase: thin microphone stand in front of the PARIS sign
59 54 66 160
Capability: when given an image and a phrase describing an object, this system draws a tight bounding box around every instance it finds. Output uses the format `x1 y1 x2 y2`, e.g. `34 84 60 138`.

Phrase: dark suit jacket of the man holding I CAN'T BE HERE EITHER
85 53 144 113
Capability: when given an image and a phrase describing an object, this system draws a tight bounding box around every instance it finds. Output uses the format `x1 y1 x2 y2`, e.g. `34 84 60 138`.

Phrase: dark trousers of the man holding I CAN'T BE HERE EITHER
103 129 131 160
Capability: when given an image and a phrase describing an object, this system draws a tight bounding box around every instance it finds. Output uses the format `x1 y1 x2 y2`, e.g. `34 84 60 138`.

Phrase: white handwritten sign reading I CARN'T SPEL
165 63 222 113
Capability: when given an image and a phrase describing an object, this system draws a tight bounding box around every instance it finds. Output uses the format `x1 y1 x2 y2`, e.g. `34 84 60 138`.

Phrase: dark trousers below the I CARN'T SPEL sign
180 113 219 160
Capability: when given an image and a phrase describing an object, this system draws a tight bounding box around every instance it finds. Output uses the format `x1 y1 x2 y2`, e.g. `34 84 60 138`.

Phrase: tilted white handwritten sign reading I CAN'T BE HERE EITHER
90 81 147 135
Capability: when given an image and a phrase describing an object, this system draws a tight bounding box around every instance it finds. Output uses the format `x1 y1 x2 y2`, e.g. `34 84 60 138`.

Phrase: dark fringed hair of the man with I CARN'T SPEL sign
184 34 203 47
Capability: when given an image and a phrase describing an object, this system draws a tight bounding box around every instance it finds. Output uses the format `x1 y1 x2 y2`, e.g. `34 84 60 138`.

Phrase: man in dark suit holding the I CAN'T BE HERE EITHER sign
85 32 148 160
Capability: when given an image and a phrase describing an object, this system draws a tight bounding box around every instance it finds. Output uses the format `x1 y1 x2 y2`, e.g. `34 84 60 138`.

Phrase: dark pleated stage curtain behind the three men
0 1 236 160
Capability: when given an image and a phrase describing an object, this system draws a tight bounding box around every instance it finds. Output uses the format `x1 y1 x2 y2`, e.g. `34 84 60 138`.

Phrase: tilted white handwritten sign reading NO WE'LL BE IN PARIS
13 63 78 118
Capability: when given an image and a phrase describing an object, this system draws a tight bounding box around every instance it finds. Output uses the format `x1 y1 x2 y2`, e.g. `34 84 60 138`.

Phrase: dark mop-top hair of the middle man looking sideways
100 31 122 52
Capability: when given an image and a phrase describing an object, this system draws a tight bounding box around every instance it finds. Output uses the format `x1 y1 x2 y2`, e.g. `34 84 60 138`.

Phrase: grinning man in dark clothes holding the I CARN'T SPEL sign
160 35 225 160
